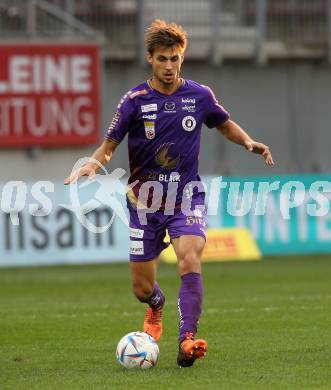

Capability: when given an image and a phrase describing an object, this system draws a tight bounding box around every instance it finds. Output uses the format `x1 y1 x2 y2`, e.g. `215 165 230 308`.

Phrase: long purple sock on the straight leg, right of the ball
178 272 203 342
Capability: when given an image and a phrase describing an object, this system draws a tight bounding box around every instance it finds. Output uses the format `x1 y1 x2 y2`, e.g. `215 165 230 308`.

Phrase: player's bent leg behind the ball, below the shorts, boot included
131 259 165 341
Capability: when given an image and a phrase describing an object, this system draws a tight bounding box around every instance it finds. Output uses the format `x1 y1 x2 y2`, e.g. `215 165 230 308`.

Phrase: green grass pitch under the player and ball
0 256 331 390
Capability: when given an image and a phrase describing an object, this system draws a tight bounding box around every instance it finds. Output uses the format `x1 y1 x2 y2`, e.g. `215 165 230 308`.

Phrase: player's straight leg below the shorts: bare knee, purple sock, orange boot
172 235 207 367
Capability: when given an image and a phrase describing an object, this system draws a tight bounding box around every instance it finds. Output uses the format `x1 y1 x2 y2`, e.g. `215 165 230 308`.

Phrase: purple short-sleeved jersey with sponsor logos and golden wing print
106 80 229 207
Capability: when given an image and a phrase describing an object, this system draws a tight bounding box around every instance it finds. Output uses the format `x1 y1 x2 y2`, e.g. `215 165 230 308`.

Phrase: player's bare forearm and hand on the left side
64 139 118 184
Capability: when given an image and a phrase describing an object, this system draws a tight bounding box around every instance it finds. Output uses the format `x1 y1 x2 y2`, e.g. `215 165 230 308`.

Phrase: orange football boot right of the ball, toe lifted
177 332 208 367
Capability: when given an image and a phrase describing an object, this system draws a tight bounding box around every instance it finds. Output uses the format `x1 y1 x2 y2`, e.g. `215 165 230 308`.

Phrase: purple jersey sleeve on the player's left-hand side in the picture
105 91 134 144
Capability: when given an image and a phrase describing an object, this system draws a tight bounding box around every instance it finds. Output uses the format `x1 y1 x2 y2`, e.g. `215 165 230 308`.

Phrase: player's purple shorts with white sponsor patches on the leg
128 196 206 262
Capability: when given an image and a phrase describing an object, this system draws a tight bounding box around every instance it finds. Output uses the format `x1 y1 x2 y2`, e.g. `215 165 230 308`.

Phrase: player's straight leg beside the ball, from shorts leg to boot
167 193 207 367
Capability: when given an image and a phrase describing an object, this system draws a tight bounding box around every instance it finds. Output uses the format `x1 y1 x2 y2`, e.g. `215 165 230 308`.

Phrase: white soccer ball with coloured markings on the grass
116 332 160 369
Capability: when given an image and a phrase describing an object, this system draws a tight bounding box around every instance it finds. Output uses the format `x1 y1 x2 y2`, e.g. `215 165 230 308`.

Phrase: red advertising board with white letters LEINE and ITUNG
0 44 100 147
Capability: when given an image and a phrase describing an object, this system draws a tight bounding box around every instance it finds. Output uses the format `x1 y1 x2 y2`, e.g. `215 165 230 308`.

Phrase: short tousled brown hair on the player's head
145 19 187 55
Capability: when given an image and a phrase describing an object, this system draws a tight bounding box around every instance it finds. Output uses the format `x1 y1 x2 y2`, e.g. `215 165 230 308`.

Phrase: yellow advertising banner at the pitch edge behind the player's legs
161 228 262 263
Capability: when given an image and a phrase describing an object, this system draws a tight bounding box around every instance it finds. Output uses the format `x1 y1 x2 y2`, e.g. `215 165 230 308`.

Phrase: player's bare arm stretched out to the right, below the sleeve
216 119 274 165
